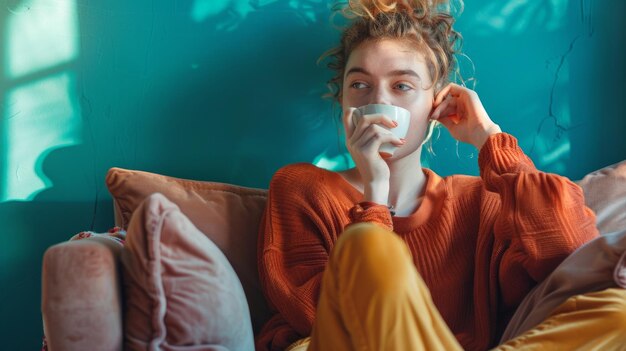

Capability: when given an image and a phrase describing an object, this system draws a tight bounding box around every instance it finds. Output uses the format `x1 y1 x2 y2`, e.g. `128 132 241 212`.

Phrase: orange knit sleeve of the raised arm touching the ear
479 133 598 311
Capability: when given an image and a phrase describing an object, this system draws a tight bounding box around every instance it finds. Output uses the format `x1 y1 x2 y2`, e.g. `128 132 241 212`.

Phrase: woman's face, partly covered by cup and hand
341 39 434 159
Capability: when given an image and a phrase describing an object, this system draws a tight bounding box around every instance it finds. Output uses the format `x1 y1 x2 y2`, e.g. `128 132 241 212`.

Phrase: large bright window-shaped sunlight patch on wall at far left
0 0 81 202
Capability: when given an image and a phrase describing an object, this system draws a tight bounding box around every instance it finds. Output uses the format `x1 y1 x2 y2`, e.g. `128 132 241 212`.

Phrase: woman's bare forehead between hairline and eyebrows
345 39 430 79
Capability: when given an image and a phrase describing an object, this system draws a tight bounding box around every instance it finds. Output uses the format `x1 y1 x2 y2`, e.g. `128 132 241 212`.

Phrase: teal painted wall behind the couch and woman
0 0 626 350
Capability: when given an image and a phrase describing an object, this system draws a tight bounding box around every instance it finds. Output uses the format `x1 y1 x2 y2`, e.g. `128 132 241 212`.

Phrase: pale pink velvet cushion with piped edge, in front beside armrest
121 193 253 350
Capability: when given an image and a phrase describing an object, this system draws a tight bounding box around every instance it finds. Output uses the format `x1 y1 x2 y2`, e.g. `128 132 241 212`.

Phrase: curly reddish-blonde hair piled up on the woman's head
322 0 463 103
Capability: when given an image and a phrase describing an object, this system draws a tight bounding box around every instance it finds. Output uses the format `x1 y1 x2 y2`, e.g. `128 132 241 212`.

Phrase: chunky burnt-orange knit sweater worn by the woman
256 133 598 350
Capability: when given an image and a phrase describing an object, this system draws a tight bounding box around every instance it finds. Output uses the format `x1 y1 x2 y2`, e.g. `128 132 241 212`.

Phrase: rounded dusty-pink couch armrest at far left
41 237 123 351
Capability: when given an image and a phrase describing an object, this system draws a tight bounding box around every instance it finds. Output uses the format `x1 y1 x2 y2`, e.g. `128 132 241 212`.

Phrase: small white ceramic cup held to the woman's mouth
352 104 411 157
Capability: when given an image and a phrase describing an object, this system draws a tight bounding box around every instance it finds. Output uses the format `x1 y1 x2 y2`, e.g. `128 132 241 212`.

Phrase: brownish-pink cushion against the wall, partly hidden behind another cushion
106 168 270 331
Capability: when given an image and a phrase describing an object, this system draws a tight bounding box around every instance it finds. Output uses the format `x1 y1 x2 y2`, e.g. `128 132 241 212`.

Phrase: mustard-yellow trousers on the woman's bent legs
287 223 626 351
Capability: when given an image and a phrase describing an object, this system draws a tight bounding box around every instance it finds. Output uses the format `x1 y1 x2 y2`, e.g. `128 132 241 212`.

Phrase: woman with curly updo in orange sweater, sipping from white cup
256 0 624 350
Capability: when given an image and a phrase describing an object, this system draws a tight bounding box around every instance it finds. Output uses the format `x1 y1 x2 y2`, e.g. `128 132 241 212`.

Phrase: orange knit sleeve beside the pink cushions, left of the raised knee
256 166 336 350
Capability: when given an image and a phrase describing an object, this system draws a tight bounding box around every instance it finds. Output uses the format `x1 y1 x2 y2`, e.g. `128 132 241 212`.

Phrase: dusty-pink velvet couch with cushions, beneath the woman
41 161 626 350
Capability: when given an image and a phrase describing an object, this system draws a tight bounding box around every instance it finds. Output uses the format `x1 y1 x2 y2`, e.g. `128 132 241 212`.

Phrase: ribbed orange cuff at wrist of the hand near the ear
478 133 535 179
